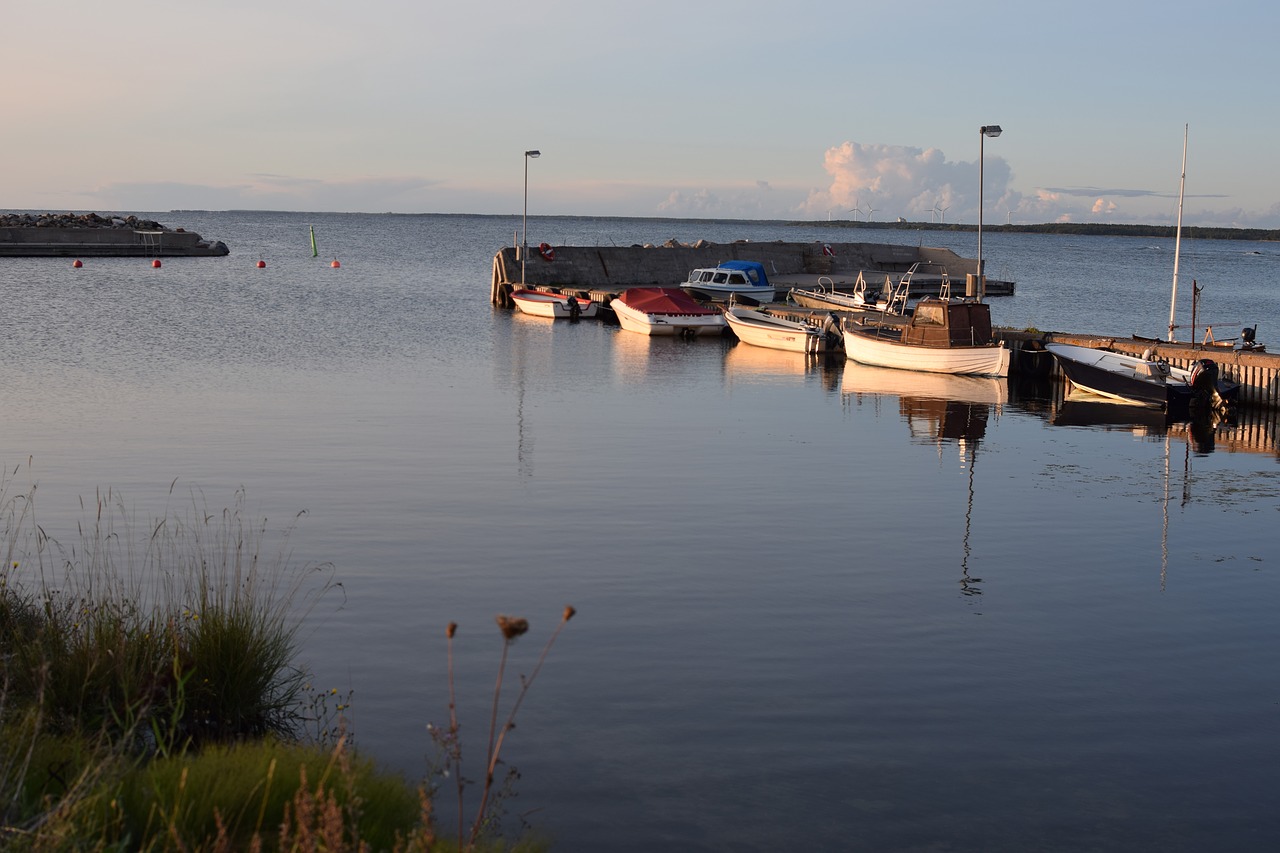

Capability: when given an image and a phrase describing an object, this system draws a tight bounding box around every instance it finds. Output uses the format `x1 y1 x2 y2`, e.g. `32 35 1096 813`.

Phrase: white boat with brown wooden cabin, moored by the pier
845 296 1010 377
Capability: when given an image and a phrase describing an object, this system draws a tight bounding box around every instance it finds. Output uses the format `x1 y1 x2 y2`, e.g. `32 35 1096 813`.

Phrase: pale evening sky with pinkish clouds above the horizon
10 0 1280 228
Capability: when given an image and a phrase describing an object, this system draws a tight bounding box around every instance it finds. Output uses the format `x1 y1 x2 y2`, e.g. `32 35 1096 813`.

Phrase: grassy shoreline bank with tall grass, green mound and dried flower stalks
0 470 573 853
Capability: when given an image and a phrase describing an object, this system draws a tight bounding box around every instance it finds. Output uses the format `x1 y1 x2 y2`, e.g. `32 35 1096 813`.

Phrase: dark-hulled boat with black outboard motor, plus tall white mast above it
1044 127 1240 416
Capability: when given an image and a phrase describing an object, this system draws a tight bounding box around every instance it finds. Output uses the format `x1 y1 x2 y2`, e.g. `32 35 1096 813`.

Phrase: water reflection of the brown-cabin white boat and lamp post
841 361 1009 596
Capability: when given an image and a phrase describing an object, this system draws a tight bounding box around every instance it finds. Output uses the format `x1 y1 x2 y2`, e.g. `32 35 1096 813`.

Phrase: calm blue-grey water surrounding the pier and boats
0 213 1280 850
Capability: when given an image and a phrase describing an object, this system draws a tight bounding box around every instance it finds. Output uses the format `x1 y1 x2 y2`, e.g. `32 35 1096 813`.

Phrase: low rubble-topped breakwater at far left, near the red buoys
0 213 230 257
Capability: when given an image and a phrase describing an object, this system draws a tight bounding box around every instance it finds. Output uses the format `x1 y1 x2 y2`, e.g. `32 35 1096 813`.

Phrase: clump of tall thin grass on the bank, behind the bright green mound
0 481 332 752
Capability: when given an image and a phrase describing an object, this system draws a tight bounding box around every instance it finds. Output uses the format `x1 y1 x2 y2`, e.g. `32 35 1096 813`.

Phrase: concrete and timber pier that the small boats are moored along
490 241 1280 409
